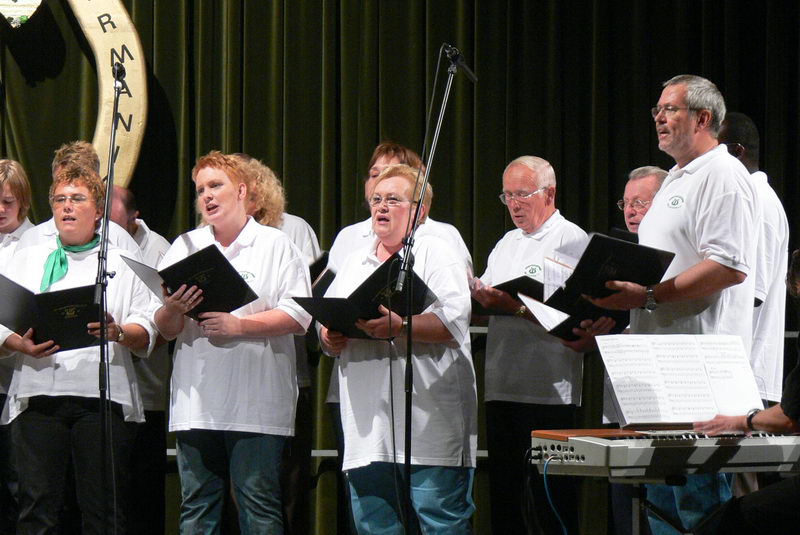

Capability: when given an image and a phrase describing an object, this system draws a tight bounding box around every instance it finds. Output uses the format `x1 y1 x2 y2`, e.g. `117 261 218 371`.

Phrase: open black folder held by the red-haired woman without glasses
122 244 258 320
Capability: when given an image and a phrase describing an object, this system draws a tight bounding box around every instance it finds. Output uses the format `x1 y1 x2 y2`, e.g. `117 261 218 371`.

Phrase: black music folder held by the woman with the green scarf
0 275 100 351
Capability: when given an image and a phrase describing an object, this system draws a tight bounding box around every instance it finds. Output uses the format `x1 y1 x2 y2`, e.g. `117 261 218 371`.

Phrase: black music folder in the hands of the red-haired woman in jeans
122 245 258 320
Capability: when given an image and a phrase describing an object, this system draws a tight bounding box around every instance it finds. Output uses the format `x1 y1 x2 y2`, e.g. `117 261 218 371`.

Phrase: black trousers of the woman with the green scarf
11 396 135 535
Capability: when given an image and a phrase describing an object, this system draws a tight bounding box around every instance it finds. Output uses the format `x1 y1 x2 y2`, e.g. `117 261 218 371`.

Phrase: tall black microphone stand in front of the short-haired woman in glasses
395 43 477 534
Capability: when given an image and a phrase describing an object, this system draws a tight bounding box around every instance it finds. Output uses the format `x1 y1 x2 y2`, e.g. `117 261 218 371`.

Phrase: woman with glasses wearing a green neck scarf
0 167 157 534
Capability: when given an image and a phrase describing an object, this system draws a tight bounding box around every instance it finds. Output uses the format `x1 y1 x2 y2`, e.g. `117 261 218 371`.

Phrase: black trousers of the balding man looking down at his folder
486 401 580 535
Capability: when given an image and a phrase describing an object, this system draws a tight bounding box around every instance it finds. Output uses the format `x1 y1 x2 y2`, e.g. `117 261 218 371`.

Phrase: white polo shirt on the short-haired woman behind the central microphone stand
326 236 477 470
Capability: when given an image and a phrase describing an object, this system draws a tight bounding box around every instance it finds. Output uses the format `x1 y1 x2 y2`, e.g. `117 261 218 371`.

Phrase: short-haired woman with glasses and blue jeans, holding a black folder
320 165 477 534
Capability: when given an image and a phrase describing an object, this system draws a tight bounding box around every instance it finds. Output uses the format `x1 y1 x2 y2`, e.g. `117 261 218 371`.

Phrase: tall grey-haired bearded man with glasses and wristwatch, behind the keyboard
592 75 761 535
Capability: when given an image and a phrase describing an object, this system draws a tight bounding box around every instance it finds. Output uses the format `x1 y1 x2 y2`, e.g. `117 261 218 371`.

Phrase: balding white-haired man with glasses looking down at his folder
472 156 587 534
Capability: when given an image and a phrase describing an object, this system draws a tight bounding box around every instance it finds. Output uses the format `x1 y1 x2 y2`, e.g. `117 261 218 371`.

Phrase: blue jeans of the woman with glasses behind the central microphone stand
347 463 475 535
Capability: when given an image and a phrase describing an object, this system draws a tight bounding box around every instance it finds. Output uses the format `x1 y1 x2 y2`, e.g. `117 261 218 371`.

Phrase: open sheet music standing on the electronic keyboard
597 334 762 429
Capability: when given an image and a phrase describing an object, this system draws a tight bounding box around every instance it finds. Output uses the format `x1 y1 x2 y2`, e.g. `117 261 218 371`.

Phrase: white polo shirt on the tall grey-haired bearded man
631 145 761 352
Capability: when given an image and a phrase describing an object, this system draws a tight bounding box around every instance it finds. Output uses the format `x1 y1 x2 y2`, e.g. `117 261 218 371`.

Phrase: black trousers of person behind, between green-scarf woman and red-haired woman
128 411 167 535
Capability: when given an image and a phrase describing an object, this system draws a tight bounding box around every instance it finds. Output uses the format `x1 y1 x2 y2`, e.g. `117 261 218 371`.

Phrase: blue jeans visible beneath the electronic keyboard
647 474 731 535
